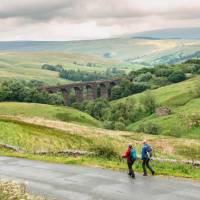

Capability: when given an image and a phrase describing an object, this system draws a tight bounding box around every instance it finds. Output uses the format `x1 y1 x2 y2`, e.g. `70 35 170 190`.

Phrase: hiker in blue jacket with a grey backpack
141 140 155 176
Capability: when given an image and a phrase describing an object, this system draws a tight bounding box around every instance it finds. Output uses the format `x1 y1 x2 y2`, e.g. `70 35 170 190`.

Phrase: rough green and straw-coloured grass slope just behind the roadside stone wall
0 114 200 159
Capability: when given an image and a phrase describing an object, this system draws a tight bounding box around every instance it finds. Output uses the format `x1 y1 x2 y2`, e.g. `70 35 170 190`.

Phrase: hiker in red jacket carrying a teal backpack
122 144 136 178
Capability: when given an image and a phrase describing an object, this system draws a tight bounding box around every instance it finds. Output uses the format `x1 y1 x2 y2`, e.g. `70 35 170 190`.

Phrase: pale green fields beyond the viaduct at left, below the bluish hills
0 52 120 85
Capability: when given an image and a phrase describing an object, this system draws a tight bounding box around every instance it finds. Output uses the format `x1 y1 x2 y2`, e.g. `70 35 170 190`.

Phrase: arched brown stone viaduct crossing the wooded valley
41 79 121 105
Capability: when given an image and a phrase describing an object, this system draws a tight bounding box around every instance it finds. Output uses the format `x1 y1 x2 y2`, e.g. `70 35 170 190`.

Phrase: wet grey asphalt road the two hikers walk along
0 157 200 200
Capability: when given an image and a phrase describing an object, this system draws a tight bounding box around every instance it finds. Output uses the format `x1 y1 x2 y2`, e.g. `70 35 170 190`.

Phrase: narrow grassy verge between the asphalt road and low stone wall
0 149 200 180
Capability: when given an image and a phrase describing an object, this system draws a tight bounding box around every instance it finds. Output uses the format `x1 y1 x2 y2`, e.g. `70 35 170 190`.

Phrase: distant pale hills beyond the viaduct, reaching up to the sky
0 29 200 85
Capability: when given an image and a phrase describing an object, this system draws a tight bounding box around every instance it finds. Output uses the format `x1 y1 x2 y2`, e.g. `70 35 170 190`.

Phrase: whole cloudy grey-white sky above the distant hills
0 0 200 41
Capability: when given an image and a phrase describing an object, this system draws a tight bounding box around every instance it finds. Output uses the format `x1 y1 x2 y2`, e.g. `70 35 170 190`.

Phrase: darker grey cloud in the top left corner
0 0 76 20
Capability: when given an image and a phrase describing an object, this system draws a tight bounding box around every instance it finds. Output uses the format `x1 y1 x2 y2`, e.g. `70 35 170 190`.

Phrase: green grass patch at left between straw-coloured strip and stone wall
0 119 97 153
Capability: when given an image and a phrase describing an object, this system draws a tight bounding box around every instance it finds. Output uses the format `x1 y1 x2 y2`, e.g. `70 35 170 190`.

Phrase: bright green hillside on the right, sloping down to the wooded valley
112 76 200 140
